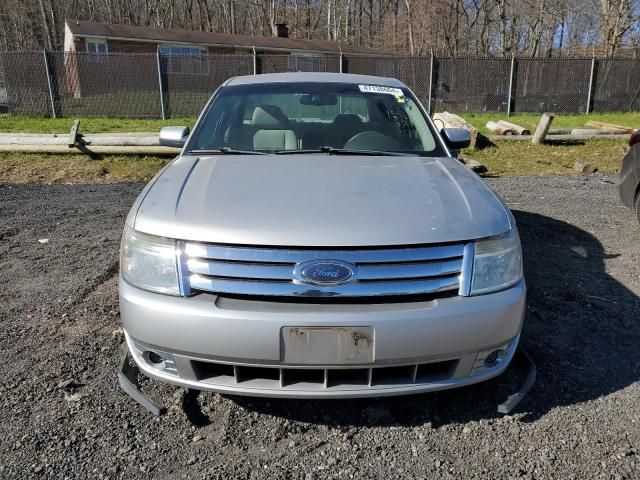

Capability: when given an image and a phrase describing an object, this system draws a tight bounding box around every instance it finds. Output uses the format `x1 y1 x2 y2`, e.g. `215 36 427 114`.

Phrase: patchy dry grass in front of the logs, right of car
462 139 628 176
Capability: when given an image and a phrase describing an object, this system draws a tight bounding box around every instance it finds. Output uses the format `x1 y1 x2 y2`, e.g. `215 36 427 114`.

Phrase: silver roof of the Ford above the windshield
226 72 406 88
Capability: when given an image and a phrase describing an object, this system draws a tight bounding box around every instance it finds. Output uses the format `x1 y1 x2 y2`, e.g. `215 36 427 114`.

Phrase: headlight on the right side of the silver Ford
471 229 522 295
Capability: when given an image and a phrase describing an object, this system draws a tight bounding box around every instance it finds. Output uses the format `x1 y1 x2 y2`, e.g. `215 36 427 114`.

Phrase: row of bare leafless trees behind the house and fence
0 0 640 57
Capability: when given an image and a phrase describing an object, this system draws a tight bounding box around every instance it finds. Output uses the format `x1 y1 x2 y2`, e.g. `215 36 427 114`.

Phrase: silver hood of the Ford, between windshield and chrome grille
134 154 512 247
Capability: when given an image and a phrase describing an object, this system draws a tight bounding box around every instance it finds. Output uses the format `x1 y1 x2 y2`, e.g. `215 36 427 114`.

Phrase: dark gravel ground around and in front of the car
0 175 640 480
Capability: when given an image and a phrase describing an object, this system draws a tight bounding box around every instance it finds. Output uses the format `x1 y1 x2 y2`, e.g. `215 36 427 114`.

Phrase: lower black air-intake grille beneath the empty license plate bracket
191 359 459 390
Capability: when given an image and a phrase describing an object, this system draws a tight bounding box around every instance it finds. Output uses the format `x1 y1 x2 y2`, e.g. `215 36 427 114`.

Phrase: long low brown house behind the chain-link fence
58 20 380 105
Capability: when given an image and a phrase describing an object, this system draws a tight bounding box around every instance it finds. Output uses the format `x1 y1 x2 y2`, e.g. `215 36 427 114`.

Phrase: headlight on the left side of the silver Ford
120 227 180 295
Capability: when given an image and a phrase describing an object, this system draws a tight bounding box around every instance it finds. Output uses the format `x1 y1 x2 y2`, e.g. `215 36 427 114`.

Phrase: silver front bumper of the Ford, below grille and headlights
120 279 526 398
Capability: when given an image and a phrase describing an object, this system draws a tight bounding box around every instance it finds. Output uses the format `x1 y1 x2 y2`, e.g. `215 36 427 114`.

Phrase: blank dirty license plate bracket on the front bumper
281 327 374 365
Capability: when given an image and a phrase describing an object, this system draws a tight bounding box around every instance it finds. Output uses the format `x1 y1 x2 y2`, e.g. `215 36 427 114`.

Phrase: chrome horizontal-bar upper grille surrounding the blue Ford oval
179 242 473 298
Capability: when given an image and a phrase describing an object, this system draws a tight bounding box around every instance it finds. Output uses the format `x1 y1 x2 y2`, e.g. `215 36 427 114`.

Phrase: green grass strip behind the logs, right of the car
462 112 640 135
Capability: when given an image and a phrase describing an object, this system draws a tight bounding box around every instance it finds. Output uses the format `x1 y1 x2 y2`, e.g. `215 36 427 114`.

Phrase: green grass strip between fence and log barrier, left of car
0 115 196 133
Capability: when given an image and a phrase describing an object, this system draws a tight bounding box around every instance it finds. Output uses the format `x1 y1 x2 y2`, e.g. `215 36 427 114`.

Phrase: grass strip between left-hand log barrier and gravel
0 153 170 183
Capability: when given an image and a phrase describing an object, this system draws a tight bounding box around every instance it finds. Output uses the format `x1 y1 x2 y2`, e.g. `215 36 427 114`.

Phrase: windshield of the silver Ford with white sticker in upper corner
187 83 444 156
